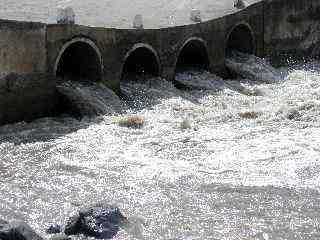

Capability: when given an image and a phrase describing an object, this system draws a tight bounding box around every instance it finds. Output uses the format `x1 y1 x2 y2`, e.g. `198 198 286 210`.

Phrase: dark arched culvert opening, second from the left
121 44 160 80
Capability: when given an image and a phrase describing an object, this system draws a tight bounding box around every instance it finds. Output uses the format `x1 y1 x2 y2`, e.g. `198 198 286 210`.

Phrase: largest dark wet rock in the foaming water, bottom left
65 204 127 239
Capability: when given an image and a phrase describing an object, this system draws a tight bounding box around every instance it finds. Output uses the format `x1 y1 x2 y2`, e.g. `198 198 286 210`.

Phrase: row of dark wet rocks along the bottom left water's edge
0 203 128 240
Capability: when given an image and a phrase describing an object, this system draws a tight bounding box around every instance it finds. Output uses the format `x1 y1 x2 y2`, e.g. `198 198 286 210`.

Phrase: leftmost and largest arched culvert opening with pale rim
55 38 103 81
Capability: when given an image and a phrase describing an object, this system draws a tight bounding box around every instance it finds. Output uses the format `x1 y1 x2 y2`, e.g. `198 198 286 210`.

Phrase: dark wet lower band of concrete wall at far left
0 73 56 124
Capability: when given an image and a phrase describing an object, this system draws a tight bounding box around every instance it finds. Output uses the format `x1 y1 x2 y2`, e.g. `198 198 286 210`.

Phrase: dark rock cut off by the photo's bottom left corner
0 221 43 240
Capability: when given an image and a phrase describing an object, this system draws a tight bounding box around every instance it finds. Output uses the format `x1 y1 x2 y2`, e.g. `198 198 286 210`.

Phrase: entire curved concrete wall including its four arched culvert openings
0 0 320 124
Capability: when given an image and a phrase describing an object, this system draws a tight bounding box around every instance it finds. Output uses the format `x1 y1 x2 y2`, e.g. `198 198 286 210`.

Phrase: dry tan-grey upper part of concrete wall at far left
0 20 47 74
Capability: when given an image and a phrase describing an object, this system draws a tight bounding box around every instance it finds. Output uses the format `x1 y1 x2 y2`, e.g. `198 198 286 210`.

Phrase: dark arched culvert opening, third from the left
176 38 210 73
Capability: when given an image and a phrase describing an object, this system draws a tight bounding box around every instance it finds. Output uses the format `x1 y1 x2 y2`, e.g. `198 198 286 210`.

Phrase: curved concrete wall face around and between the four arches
47 0 263 91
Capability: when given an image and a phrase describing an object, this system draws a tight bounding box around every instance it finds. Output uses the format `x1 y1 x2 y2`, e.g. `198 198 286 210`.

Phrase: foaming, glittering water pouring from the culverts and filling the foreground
0 53 320 240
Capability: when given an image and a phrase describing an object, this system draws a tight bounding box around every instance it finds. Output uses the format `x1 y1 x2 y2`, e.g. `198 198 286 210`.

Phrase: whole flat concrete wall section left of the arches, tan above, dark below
0 20 55 124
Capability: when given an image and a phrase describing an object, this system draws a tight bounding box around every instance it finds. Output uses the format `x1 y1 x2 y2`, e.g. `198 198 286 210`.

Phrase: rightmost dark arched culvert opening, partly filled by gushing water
225 24 256 57
